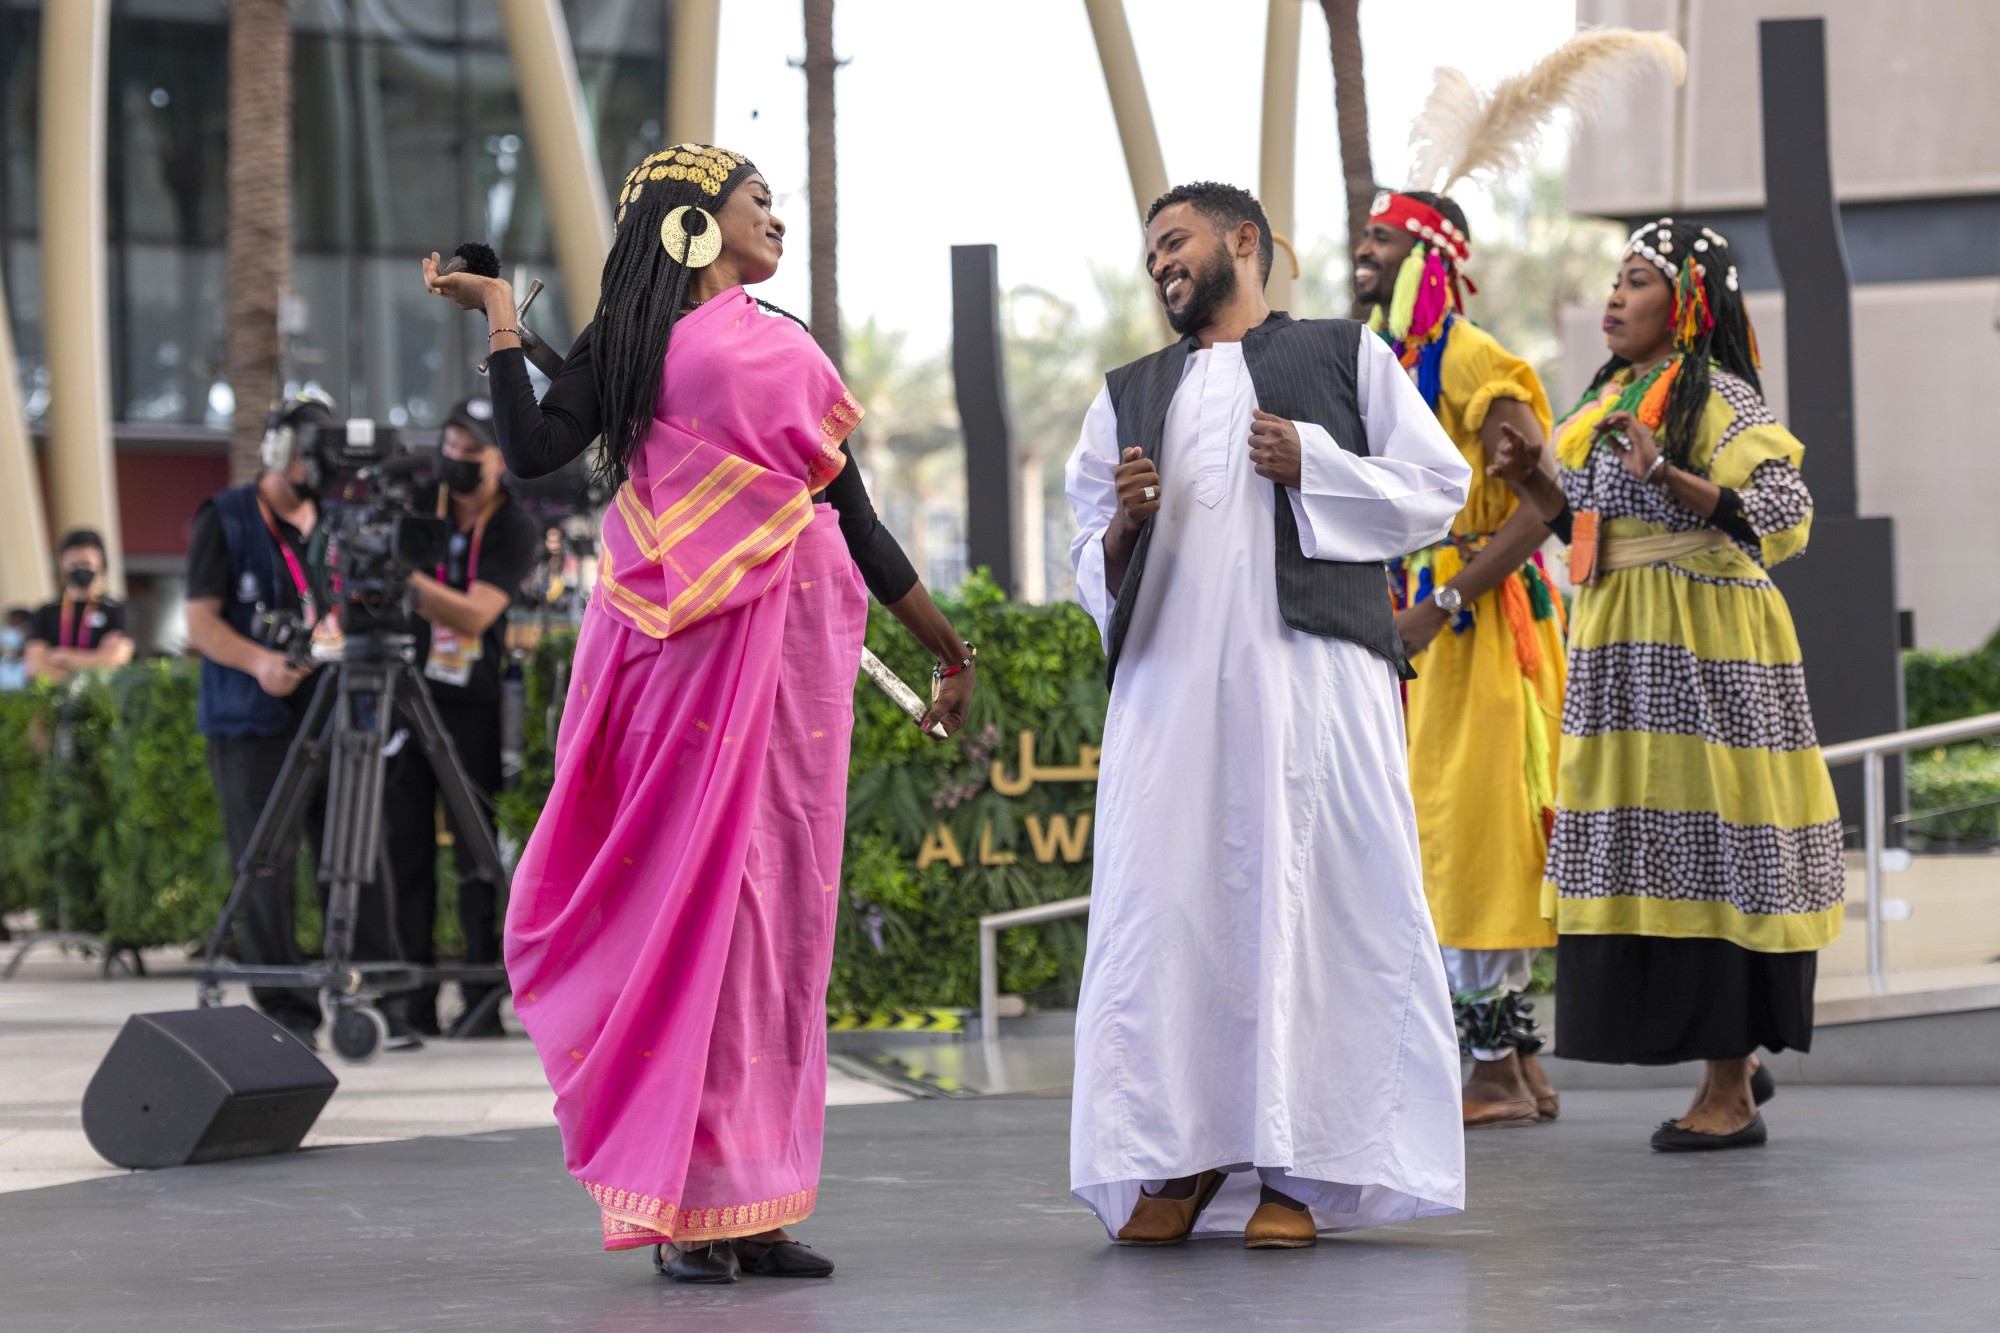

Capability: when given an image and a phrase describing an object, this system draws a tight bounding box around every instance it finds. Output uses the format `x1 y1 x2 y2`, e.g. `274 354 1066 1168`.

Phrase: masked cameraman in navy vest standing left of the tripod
188 396 406 1049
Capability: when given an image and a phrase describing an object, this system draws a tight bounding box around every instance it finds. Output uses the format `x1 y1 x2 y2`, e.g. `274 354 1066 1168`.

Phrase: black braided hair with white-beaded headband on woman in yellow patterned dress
1584 218 1764 466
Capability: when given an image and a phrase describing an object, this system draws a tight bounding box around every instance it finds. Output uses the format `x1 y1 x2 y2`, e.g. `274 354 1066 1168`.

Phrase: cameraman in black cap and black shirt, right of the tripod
384 396 540 1037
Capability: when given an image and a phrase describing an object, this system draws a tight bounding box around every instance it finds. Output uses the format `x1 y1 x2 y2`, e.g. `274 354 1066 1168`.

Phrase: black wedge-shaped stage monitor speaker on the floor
84 1005 340 1167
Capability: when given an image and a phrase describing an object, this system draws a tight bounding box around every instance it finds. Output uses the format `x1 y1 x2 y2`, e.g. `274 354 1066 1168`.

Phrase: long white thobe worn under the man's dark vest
1066 336 1470 1235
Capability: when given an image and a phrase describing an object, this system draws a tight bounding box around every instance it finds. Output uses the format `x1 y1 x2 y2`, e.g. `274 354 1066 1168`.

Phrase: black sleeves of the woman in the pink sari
488 328 916 606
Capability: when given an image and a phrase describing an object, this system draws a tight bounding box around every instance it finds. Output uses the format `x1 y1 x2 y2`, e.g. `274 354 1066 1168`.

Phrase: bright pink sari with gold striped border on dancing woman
506 288 866 1249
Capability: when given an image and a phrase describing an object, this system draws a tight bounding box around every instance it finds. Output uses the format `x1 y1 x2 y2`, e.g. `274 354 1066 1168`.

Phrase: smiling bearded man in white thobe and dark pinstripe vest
1066 182 1470 1247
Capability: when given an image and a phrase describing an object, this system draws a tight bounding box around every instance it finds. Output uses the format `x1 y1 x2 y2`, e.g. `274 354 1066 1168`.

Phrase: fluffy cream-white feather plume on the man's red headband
1410 28 1688 192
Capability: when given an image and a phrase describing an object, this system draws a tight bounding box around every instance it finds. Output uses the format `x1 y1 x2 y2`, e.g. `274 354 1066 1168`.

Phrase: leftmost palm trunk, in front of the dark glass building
228 0 292 482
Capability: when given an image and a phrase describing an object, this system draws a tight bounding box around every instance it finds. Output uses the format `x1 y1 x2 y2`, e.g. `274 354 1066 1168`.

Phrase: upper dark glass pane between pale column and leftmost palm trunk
110 20 228 246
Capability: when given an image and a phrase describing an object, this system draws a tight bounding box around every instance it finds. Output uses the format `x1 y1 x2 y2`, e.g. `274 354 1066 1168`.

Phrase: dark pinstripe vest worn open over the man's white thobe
1104 310 1416 681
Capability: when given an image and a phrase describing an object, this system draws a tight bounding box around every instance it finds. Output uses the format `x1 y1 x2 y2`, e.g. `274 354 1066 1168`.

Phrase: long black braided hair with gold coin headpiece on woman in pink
592 144 804 486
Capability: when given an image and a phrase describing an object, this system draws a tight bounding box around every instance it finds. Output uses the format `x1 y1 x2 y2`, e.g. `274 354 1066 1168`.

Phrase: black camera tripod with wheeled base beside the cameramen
194 630 506 1061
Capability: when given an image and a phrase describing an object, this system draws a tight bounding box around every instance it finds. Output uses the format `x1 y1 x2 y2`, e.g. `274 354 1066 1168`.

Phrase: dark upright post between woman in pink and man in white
952 246 1020 596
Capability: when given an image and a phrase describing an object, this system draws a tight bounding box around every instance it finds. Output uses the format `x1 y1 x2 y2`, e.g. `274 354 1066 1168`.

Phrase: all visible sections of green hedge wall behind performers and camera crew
0 600 2000 984
